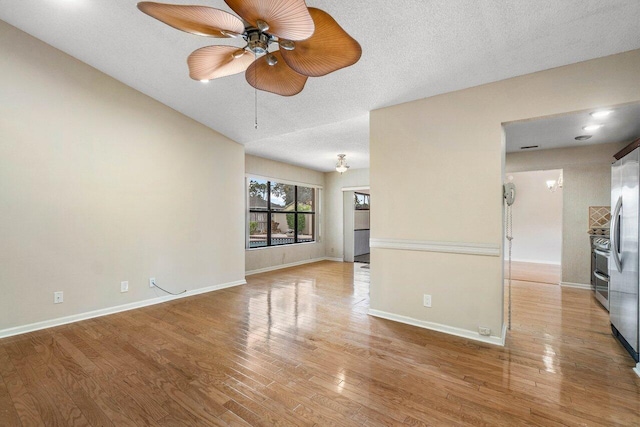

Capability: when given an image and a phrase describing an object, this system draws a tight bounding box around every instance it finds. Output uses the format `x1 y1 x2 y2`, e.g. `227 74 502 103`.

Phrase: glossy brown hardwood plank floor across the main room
0 261 640 426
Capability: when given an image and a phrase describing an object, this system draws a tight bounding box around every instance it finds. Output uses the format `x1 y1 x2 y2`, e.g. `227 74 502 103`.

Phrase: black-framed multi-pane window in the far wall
249 178 316 248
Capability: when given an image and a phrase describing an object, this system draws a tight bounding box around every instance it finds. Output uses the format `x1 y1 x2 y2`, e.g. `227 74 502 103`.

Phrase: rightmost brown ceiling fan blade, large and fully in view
280 7 362 77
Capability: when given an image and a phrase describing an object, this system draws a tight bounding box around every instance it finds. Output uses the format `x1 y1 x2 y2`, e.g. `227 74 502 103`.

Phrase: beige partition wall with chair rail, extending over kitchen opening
370 51 640 342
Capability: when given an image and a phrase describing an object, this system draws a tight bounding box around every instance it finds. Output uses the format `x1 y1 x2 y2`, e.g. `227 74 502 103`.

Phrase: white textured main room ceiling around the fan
0 0 640 171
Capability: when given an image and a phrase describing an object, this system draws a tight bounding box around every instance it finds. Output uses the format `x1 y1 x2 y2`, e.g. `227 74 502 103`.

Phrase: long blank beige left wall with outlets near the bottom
0 21 244 331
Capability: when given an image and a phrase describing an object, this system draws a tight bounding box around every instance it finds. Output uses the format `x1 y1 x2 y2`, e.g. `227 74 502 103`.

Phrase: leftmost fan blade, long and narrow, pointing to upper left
138 1 244 38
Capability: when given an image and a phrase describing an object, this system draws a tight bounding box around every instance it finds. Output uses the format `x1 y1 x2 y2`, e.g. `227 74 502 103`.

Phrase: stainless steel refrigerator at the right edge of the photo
609 148 640 362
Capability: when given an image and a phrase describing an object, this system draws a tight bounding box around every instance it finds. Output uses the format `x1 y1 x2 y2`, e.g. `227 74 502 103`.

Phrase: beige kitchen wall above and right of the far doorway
505 142 627 285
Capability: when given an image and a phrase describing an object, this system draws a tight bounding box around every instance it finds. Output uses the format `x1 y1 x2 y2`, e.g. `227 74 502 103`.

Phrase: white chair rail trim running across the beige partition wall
369 238 500 256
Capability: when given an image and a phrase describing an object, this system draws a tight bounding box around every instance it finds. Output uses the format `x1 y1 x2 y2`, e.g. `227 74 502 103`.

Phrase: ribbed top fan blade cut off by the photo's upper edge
224 0 313 40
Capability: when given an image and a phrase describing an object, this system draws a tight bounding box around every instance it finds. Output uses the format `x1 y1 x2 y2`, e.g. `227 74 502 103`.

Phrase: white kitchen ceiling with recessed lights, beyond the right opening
504 102 640 153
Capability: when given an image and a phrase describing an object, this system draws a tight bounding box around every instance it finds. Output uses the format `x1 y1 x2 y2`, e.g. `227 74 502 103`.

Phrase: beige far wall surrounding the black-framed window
243 155 326 272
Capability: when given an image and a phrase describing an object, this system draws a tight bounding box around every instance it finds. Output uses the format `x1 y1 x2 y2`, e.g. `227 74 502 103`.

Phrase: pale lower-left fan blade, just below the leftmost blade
187 46 254 80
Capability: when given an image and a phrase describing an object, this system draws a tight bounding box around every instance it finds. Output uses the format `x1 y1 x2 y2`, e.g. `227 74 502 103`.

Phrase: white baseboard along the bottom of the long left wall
0 280 247 338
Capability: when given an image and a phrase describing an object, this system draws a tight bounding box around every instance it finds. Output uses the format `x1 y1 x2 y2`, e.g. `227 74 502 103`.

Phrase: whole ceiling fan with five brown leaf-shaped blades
138 0 362 96
